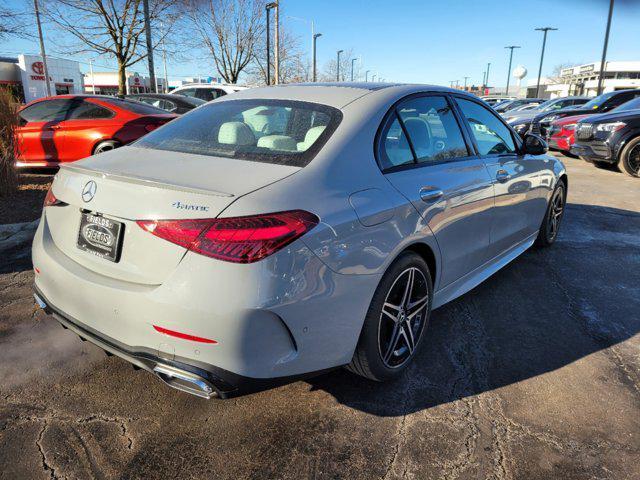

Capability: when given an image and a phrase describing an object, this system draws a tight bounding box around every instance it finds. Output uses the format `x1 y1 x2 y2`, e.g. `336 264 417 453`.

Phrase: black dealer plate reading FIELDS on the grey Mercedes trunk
78 213 124 262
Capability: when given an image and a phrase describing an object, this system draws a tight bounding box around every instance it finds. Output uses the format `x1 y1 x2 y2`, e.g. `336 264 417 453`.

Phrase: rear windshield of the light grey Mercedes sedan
136 99 342 167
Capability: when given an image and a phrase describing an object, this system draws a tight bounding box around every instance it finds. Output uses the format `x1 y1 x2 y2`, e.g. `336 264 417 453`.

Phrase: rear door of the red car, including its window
60 98 115 162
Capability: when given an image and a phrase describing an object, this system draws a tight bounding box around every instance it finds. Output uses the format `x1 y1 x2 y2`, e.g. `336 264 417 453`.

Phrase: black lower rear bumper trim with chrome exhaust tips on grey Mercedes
34 286 338 399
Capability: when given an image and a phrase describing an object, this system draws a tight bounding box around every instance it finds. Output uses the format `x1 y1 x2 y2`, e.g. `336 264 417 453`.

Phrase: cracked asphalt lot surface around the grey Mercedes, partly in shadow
0 158 640 479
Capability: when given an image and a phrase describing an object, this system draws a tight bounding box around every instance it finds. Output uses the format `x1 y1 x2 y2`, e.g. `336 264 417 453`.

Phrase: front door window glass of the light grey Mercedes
456 98 516 155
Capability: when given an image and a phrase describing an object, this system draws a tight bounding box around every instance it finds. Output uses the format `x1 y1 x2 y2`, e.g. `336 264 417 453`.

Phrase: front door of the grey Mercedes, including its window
455 96 551 258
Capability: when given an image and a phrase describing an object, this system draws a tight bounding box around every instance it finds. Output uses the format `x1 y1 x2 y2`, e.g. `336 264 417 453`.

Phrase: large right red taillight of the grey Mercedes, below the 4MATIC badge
137 210 319 263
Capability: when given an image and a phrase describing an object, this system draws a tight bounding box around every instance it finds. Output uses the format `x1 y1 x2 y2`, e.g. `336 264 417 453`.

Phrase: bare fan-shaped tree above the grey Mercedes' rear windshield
187 0 265 83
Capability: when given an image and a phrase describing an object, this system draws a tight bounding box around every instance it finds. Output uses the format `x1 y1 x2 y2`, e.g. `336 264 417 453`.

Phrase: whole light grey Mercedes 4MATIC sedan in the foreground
33 83 568 398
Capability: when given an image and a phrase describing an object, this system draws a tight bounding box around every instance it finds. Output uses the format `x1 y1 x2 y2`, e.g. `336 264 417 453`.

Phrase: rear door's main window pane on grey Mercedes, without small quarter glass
397 96 469 163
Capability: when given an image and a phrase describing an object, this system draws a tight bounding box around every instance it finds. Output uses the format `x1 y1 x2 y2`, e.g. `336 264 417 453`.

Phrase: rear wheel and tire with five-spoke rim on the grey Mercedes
347 252 433 382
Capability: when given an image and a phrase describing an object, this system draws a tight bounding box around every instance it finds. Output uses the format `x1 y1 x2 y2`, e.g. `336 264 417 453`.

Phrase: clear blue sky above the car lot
0 0 640 86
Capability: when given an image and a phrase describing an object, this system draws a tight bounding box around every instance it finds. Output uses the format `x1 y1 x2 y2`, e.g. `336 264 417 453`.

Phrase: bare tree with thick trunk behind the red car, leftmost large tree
45 0 176 94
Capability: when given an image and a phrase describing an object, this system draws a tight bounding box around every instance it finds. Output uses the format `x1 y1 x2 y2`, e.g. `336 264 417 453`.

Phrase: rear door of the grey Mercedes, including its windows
377 94 493 288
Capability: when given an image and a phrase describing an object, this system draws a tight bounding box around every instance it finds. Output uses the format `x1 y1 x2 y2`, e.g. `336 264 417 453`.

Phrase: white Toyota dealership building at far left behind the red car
0 55 84 102
